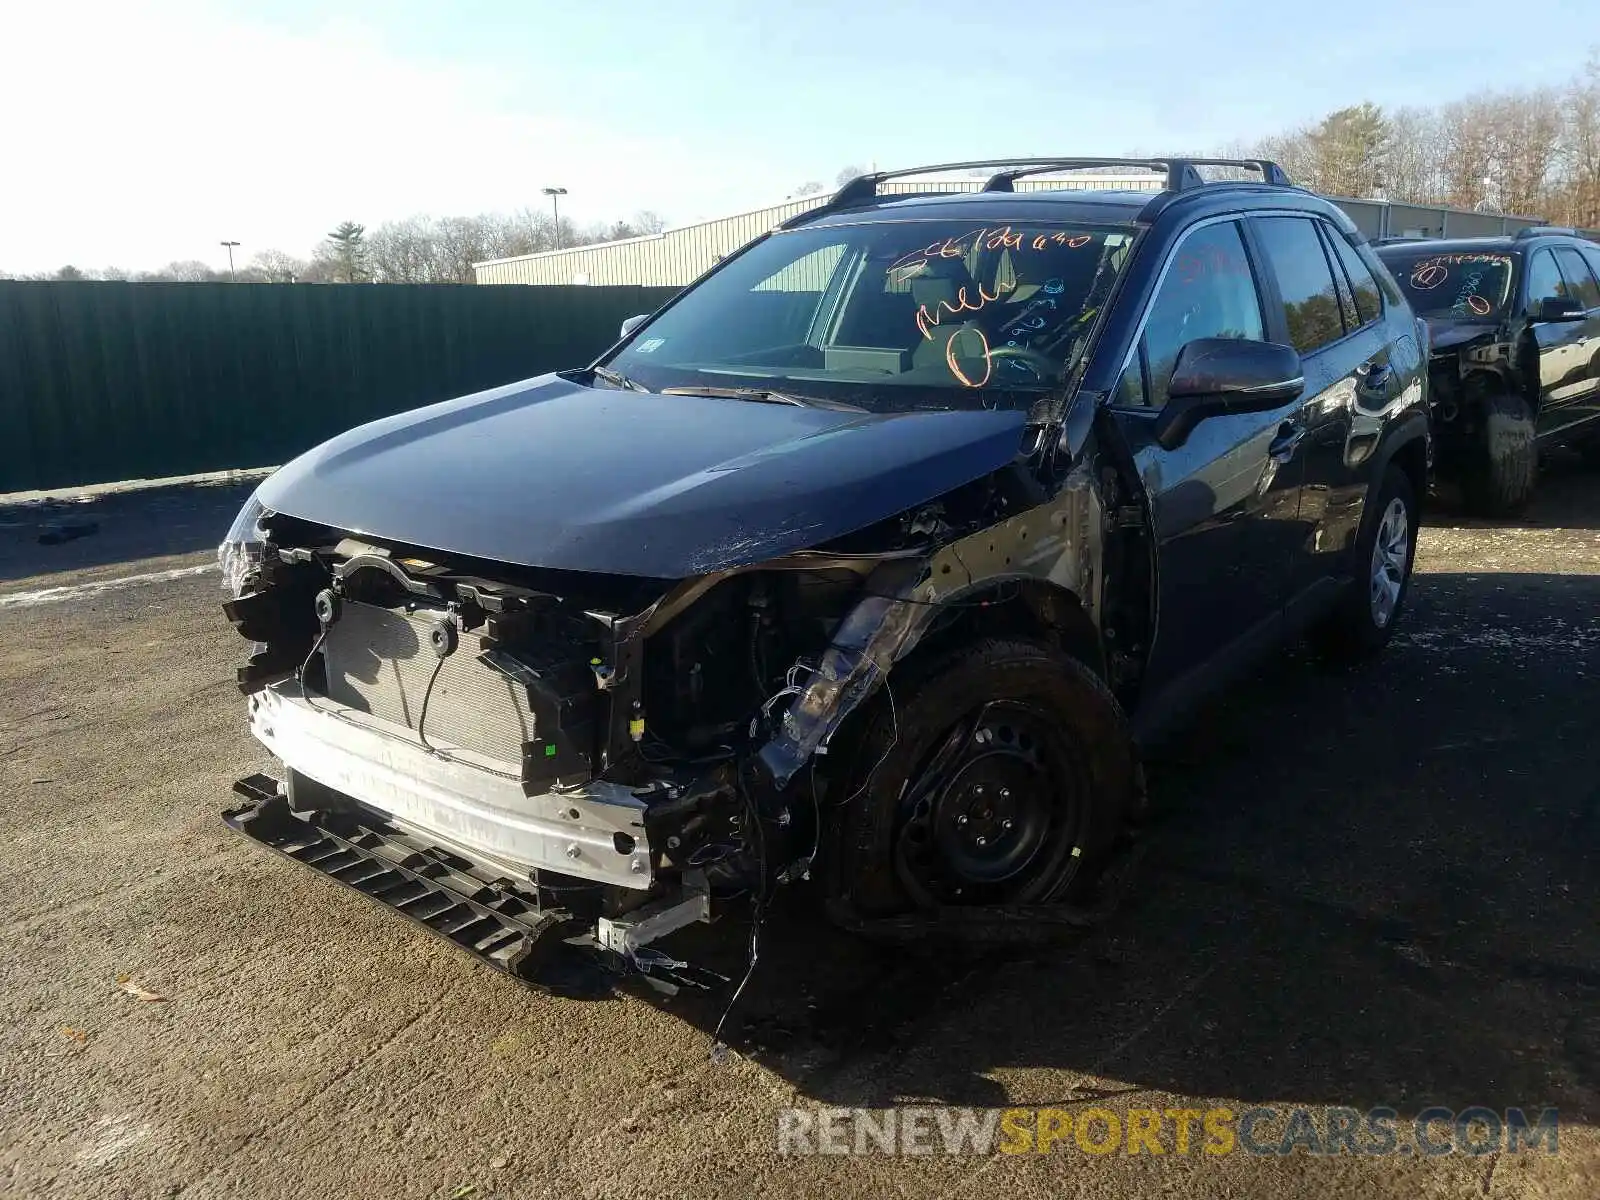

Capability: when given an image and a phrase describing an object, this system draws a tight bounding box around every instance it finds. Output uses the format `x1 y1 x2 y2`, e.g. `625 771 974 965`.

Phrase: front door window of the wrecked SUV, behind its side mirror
1117 221 1267 408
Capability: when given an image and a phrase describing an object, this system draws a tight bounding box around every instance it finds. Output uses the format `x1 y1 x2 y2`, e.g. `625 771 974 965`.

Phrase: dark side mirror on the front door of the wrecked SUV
1155 338 1306 450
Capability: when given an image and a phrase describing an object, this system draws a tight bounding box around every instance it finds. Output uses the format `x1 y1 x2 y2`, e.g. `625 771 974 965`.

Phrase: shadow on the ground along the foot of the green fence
0 480 256 584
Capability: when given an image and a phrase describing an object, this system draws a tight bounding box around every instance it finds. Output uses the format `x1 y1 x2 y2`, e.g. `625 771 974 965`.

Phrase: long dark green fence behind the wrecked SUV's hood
0 280 675 493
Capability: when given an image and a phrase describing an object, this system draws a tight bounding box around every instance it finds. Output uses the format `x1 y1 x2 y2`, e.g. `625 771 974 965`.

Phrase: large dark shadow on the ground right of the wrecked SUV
636 574 1600 1122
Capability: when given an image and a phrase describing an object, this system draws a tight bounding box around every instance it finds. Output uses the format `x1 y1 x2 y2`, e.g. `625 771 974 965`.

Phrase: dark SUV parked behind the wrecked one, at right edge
1378 227 1600 517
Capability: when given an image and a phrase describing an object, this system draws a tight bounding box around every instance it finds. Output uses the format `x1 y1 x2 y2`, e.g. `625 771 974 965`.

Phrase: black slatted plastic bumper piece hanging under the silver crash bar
222 774 728 995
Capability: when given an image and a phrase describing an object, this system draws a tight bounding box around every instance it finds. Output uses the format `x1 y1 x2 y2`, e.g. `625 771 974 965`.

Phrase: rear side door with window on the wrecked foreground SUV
1248 216 1398 616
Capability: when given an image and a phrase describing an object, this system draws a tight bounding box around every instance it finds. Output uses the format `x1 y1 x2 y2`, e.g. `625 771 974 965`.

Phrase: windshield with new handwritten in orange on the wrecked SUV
606 221 1133 413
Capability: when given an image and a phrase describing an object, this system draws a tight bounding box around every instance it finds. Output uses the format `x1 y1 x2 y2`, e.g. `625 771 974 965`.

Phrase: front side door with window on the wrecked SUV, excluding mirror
1112 219 1301 688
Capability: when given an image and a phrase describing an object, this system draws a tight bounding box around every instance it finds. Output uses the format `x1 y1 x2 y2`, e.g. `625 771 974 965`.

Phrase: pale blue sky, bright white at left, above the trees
0 0 1600 272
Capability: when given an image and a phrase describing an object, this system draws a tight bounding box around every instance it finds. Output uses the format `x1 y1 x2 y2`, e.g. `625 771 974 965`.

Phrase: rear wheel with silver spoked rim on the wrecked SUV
1310 466 1418 662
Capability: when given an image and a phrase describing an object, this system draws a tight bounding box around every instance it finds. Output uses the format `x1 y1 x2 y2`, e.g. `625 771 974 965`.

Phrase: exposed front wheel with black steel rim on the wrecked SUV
826 638 1144 918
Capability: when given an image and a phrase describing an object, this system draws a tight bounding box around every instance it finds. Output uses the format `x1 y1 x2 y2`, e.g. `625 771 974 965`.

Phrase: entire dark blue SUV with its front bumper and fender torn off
221 158 1429 987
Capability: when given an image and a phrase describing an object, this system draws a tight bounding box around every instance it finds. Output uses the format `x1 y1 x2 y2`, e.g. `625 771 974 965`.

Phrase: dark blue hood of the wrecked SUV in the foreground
258 374 1026 579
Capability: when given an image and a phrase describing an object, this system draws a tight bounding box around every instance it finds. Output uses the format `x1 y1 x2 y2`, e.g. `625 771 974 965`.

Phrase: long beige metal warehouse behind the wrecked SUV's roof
472 173 1574 286
